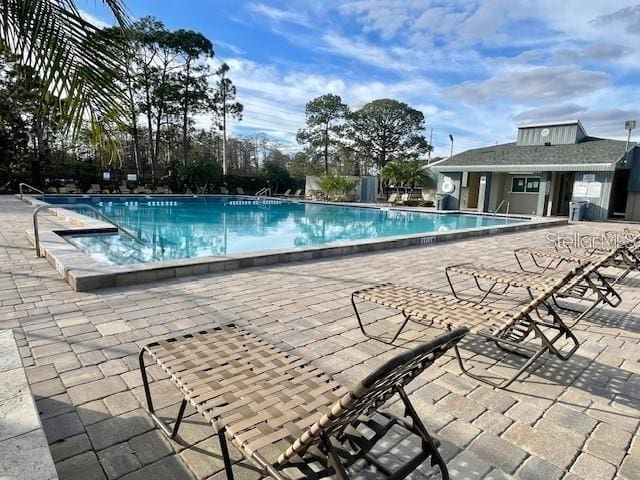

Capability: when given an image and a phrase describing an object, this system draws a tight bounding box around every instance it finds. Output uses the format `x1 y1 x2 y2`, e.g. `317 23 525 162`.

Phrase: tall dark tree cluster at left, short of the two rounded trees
0 17 296 191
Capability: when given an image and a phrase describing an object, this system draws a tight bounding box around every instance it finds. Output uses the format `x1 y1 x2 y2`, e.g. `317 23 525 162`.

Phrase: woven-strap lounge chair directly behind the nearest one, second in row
351 266 595 388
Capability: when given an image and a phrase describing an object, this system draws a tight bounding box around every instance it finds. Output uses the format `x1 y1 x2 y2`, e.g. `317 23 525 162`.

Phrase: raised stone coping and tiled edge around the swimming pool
18 193 568 291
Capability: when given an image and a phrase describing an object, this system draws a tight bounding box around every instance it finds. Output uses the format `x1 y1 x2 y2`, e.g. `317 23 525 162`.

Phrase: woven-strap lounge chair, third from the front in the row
445 249 622 326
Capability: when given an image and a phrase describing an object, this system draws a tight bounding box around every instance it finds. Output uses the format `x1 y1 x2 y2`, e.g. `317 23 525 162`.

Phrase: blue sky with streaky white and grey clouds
79 0 640 155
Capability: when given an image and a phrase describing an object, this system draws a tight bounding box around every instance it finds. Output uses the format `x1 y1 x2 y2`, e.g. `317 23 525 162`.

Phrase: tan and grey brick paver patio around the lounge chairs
0 197 640 480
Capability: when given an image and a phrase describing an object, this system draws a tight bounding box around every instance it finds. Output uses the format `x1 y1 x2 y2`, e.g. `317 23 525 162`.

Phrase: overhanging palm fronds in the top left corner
0 0 128 153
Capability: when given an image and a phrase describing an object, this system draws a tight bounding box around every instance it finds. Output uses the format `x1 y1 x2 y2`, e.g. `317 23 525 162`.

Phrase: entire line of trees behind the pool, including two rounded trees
0 13 432 191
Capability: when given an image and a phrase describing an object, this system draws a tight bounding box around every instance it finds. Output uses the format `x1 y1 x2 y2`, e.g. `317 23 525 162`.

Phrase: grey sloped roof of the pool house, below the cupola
432 137 635 172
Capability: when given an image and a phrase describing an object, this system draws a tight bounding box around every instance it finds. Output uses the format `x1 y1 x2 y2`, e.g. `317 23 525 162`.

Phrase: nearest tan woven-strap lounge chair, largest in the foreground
139 326 467 480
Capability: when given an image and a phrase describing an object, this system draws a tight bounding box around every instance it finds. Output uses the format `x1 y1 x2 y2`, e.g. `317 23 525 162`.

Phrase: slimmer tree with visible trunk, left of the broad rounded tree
296 93 349 173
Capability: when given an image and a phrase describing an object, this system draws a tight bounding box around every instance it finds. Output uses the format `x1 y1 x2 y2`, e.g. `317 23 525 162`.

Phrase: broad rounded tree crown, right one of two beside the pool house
347 99 432 168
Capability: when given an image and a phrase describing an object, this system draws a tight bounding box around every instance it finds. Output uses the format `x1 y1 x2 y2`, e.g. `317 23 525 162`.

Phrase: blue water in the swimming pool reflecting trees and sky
46 196 527 264
